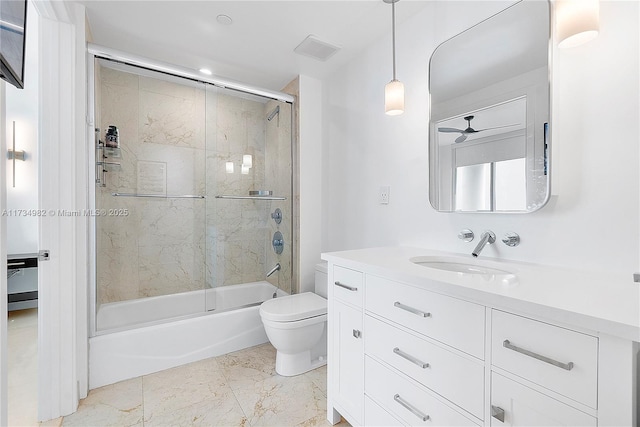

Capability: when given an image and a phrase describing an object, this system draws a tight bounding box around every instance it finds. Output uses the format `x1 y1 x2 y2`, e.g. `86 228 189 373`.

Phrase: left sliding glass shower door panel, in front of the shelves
95 60 206 331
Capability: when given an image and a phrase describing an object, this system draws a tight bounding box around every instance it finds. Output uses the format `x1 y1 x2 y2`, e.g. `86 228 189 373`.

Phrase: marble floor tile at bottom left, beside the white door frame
62 377 143 427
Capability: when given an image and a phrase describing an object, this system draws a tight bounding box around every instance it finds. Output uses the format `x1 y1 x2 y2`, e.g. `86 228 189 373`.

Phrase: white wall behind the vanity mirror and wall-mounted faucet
323 0 640 278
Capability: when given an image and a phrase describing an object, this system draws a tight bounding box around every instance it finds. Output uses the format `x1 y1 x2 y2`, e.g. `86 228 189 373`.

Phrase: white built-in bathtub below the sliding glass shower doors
89 282 286 389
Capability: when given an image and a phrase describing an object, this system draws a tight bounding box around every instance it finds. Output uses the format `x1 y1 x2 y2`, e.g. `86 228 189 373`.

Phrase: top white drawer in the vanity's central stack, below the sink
365 275 485 359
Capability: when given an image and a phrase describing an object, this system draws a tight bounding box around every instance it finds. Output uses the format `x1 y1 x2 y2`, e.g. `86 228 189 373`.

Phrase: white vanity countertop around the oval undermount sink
322 247 640 342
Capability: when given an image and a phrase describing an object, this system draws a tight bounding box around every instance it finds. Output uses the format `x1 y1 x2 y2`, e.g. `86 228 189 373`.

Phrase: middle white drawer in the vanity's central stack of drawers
364 316 484 419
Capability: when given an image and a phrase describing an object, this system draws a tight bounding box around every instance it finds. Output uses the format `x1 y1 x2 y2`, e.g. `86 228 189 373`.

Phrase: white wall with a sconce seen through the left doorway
5 2 39 254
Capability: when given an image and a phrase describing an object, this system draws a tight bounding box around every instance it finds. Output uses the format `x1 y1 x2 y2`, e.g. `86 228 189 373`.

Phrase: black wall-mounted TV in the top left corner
0 0 27 89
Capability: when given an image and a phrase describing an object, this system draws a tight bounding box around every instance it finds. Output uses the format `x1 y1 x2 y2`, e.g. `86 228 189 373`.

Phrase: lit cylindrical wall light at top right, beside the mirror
555 0 600 49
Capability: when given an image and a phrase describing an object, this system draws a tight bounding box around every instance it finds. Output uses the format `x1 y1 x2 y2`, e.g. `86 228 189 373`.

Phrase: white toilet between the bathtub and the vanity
260 263 327 377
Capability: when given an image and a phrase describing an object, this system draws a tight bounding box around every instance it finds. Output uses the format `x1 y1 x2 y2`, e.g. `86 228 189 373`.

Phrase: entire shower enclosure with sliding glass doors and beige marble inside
90 47 294 336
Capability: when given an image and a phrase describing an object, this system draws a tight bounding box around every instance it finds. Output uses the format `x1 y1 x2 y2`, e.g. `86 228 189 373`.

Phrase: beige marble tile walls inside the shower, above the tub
96 67 291 310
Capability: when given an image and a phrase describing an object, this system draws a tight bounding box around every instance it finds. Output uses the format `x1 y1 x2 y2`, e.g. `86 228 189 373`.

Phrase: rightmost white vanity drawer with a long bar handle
491 310 598 409
